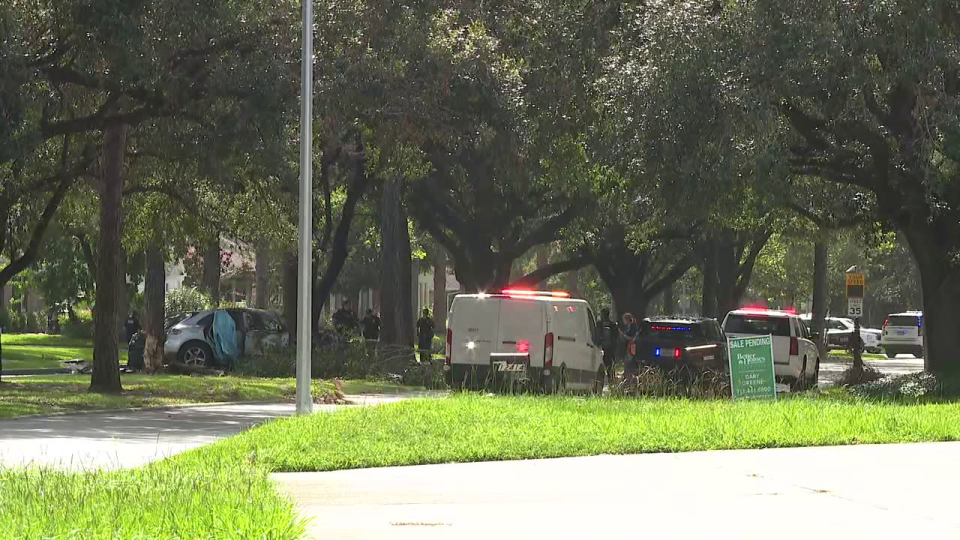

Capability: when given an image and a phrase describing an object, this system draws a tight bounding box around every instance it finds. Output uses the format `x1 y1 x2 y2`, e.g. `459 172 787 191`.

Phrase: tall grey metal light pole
297 0 313 414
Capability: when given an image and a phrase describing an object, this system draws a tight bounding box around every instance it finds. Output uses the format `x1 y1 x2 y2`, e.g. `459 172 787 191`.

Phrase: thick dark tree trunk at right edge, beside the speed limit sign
904 232 960 376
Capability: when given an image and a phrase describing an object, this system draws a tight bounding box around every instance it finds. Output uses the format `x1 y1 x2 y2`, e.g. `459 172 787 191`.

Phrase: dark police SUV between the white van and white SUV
637 317 729 375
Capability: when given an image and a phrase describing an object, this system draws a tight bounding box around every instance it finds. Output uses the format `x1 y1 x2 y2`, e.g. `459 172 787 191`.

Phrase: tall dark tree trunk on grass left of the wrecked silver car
90 124 127 392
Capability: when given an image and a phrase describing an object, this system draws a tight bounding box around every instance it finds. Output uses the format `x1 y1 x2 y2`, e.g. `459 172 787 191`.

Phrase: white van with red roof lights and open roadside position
444 290 604 392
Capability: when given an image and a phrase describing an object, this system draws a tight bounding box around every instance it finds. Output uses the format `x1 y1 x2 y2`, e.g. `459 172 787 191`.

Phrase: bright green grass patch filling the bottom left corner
0 460 305 540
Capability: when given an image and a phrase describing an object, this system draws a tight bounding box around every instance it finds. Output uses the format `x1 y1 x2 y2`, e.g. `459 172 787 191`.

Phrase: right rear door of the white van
496 297 547 367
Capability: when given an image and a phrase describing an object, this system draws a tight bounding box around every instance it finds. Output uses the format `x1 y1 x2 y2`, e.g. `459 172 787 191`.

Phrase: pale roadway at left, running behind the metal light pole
0 395 402 469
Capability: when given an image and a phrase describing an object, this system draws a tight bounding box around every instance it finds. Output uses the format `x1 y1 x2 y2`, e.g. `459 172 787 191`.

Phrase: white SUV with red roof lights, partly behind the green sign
723 308 820 390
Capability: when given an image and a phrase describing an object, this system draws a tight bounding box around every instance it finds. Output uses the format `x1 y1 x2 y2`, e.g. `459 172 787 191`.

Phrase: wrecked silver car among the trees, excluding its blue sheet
163 308 290 366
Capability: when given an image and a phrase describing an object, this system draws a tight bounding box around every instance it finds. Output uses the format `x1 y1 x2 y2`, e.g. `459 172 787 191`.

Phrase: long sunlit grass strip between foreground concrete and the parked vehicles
174 395 960 471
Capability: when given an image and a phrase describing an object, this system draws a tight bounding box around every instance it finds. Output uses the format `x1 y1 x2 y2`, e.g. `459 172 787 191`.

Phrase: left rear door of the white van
450 296 501 365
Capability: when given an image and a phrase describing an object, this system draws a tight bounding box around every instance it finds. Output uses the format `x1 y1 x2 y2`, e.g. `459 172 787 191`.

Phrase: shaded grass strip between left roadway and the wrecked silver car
0 375 424 418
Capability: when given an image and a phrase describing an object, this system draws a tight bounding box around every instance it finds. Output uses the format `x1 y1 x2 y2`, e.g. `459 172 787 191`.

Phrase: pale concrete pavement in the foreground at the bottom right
274 443 960 540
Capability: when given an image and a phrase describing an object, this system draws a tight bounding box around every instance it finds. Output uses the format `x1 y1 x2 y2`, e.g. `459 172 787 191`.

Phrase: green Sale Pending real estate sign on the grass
727 336 777 399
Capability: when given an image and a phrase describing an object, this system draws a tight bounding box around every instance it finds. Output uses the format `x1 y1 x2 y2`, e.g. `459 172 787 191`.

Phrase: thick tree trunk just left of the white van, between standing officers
380 179 413 347
